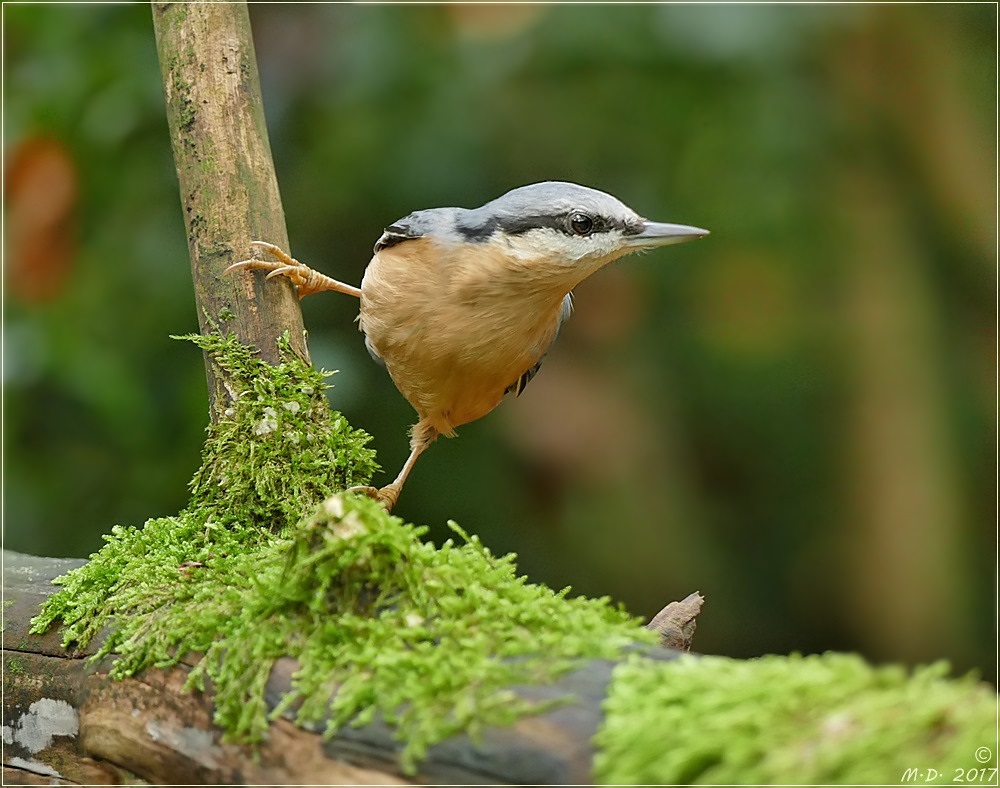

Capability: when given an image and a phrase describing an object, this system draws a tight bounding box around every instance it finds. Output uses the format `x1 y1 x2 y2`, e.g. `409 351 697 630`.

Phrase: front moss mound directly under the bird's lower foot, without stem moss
195 495 648 769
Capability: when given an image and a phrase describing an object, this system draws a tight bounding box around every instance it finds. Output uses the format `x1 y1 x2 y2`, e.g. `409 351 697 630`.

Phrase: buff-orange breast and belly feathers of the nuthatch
360 239 565 434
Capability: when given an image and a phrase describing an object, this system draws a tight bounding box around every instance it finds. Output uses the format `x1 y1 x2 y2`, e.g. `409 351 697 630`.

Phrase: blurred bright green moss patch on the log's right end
595 653 996 785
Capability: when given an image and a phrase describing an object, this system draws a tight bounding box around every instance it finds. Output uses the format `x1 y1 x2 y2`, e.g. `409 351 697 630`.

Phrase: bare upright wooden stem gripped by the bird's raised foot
153 2 308 420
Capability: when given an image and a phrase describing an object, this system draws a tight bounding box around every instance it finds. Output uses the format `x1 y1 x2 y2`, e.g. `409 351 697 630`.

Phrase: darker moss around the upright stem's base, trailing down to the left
32 332 377 656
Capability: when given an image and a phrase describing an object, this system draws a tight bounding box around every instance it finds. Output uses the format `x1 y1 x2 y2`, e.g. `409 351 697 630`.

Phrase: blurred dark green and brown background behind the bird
3 4 997 677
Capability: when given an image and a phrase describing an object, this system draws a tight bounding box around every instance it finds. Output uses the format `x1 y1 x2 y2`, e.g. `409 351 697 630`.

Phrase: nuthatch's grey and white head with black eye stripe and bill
454 181 708 289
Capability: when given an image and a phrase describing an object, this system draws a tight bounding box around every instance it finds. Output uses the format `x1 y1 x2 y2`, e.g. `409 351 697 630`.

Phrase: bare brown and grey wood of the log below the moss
3 551 677 785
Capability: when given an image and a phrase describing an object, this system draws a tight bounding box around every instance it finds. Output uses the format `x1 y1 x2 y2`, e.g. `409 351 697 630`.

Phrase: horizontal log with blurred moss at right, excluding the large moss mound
3 540 997 785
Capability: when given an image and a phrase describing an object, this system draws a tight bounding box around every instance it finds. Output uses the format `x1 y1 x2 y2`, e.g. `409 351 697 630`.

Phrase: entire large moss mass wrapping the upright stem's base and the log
33 324 653 768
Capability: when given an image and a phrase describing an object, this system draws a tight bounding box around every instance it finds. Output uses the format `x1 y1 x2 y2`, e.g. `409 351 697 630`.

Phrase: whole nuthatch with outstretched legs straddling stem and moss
226 181 708 509
